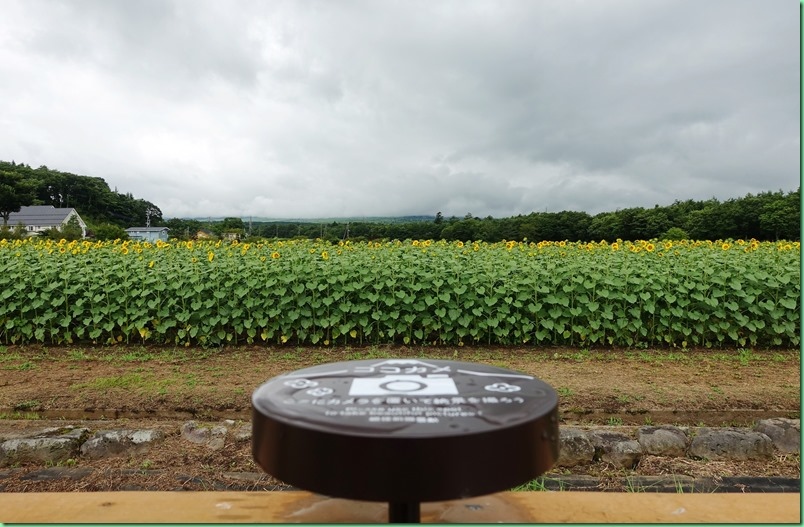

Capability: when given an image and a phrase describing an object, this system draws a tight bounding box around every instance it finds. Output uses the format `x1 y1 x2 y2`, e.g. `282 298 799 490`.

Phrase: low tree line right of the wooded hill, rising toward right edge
165 187 801 242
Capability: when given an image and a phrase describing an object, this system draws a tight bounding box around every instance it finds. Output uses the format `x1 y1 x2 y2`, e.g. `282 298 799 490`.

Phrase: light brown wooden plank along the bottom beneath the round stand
0 491 801 524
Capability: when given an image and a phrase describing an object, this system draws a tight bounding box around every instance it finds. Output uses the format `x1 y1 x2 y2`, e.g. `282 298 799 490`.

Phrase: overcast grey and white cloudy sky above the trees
0 0 801 218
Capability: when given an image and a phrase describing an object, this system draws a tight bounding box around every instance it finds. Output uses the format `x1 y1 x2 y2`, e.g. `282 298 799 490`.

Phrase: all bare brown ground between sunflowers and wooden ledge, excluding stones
0 346 801 491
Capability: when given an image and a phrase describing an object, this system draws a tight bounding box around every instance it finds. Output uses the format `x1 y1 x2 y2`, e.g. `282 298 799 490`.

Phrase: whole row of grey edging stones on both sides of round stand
0 418 801 469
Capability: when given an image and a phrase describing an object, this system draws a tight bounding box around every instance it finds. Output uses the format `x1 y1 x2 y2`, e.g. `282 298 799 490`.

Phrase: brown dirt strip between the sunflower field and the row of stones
0 347 801 426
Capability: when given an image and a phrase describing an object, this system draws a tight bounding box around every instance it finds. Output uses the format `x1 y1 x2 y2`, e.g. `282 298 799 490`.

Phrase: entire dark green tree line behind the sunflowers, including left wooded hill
0 161 801 242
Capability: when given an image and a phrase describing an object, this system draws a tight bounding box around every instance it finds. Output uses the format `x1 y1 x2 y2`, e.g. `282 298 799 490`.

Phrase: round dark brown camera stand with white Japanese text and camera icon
252 359 558 523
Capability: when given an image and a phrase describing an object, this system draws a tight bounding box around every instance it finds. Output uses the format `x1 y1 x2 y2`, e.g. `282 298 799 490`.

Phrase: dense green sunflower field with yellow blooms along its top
0 238 801 347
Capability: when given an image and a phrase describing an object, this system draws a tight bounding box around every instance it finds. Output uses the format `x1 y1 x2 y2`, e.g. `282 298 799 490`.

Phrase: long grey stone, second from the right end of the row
688 428 773 461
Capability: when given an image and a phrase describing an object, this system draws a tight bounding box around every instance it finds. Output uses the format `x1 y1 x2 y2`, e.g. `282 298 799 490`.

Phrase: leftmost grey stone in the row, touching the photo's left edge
0 427 89 467
